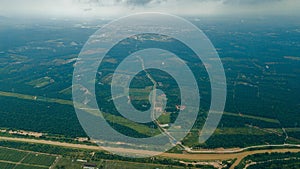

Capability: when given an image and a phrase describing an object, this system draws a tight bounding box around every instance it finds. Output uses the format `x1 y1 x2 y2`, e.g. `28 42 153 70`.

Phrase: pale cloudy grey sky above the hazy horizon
0 0 300 18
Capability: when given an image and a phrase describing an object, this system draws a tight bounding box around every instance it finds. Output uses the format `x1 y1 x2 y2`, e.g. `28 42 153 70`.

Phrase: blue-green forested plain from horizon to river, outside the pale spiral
0 17 300 148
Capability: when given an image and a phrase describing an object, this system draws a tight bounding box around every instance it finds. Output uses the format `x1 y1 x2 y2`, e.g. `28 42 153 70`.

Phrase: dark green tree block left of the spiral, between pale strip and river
0 96 86 138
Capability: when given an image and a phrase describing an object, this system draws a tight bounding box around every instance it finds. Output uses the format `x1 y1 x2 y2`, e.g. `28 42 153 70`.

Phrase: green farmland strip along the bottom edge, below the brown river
0 141 220 169
